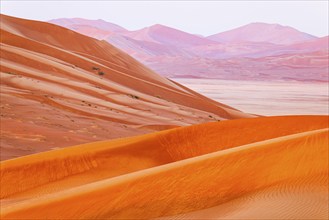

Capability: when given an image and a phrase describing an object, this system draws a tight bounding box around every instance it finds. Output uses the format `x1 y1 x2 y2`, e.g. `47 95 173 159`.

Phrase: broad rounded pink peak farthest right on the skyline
207 23 316 45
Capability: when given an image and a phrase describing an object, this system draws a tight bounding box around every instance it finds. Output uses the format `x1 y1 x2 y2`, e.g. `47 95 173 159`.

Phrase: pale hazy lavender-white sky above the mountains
1 0 329 37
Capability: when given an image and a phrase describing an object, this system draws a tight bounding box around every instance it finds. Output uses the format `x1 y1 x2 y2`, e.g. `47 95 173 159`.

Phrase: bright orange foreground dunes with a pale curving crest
1 116 329 219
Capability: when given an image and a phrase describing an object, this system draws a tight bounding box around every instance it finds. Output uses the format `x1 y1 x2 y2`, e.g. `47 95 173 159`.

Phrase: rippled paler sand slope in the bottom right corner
157 173 329 220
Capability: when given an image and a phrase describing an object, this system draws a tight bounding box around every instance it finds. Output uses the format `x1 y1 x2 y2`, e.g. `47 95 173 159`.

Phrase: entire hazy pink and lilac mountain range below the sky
49 18 329 81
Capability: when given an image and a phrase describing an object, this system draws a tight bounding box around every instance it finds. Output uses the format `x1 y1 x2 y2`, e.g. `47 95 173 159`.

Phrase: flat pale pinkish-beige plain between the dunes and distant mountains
173 78 329 116
